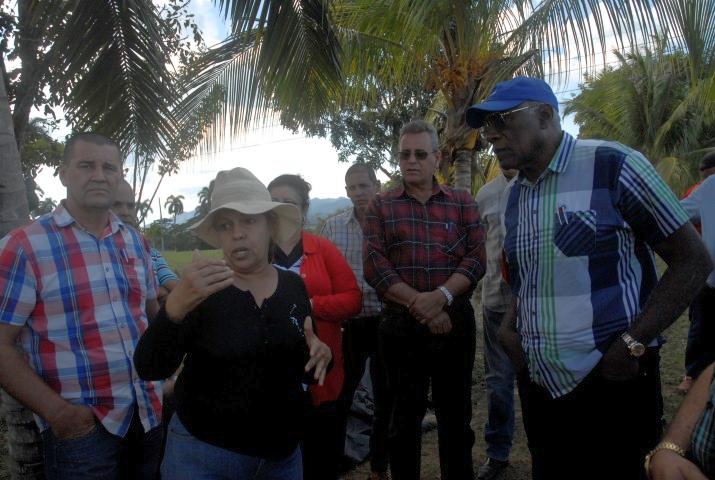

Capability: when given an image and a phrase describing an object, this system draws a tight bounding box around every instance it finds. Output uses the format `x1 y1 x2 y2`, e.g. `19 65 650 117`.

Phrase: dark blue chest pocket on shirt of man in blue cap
554 208 598 257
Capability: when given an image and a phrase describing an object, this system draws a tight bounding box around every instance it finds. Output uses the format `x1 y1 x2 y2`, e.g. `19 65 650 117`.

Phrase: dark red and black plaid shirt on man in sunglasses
363 181 486 296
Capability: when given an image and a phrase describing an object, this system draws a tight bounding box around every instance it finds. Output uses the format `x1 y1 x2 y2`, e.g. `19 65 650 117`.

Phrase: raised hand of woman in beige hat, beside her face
166 250 233 323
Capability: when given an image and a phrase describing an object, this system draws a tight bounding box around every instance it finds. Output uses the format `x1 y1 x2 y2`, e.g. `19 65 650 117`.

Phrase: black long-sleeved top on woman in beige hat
134 269 310 459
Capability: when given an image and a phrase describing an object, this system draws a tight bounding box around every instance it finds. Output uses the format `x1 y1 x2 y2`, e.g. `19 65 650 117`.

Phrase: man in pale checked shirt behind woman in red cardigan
320 163 390 480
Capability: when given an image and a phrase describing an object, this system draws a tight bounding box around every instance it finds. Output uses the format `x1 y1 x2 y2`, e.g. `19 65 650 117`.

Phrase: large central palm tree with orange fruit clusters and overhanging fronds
180 0 692 191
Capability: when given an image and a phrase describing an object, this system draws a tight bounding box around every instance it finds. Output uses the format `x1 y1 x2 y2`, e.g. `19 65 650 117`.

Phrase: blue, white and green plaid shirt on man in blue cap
504 133 688 398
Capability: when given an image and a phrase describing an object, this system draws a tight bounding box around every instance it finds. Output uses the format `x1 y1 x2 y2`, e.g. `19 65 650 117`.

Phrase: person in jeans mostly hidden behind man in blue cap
476 169 518 480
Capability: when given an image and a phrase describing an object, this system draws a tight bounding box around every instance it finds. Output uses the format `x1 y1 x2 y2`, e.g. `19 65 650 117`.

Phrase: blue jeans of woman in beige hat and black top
161 414 303 480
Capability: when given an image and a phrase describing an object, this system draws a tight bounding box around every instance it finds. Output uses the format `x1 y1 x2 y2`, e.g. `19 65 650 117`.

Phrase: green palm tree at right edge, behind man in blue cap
566 1 715 193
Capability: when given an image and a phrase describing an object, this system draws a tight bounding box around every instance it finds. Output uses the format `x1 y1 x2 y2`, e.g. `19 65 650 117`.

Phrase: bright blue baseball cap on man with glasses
467 77 559 128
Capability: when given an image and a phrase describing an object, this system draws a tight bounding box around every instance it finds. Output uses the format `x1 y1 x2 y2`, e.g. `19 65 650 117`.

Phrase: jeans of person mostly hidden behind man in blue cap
483 308 514 461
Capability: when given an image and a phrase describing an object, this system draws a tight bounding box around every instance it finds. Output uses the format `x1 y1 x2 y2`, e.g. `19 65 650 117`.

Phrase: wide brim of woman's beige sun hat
189 201 301 248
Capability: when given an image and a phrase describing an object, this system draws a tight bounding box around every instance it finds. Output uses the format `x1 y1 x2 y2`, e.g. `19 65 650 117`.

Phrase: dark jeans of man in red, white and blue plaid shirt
42 408 162 480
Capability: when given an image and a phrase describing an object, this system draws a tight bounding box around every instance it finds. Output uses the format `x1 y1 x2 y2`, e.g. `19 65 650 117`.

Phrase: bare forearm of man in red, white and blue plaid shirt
0 345 67 422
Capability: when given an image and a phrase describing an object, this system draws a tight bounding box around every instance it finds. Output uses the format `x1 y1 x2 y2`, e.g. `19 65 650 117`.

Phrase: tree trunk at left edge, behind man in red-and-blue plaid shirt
0 68 44 480
